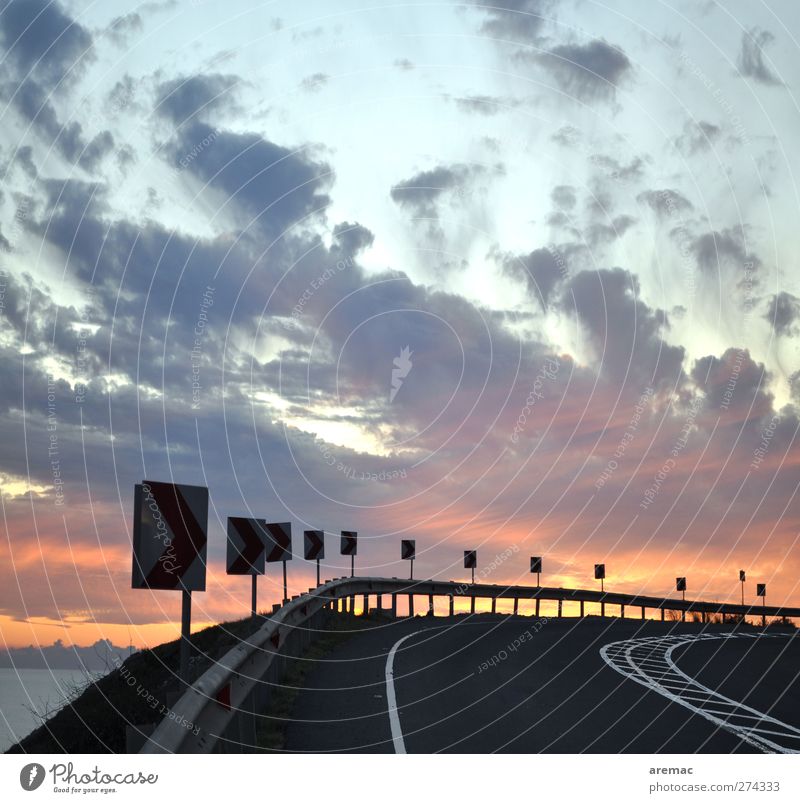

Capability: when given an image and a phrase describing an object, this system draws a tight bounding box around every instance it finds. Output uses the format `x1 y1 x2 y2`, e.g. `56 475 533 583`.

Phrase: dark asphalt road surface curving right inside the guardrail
286 615 800 754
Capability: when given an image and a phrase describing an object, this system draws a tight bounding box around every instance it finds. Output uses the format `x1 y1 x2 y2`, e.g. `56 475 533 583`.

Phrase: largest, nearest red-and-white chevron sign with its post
131 480 208 683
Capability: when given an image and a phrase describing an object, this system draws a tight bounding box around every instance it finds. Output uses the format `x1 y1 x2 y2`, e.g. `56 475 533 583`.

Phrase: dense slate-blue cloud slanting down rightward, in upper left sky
170 121 333 237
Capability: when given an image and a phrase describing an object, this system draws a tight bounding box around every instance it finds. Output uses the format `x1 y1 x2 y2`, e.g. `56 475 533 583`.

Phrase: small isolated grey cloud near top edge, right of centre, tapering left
518 39 633 103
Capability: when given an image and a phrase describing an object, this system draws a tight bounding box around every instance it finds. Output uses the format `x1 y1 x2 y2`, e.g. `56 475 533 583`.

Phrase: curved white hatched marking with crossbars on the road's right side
600 633 800 753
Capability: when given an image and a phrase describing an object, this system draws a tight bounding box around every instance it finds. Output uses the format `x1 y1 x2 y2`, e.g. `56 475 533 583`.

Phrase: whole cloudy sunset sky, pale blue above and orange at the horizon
0 0 800 647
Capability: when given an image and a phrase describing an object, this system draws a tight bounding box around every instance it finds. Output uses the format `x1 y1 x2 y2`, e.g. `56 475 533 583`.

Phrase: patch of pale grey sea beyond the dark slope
0 669 97 753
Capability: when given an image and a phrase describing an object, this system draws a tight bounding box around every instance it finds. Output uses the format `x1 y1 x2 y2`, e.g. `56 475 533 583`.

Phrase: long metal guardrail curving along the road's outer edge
140 577 800 753
